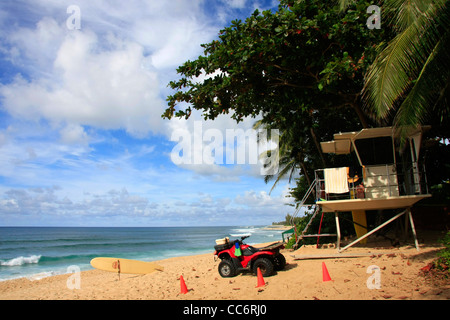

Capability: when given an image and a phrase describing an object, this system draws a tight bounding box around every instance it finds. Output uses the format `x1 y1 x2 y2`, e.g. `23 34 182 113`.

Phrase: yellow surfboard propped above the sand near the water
91 257 164 274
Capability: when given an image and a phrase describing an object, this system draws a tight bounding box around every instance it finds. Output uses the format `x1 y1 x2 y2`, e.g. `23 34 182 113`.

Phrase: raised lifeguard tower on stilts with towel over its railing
293 127 431 252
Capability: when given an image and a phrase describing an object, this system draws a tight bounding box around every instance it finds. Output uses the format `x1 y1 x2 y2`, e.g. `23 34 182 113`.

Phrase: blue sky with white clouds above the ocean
0 0 293 226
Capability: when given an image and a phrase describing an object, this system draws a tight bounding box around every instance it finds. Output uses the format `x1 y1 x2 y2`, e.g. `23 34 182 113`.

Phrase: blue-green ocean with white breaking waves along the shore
0 226 282 281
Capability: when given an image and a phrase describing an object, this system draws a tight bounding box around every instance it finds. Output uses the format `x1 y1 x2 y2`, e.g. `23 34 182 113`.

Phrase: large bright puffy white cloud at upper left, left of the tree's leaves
0 25 164 135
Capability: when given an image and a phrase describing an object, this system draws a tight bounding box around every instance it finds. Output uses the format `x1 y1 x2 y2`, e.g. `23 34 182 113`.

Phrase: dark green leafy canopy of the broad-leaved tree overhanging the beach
163 0 383 130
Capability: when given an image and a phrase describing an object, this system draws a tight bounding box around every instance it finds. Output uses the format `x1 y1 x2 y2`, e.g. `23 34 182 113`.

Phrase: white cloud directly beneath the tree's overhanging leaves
168 110 270 181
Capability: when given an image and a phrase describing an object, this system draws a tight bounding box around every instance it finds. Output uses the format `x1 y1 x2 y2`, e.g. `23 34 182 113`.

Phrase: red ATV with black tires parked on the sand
214 236 286 278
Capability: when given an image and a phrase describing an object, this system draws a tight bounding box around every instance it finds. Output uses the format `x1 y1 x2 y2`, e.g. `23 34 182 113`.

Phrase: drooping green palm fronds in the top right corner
339 0 450 138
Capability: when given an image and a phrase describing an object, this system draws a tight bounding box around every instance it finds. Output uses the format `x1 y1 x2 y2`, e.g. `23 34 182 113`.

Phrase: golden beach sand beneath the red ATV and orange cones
0 232 450 300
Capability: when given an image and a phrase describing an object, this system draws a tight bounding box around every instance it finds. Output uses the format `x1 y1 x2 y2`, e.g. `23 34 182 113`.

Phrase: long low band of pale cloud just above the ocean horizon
0 180 289 226
